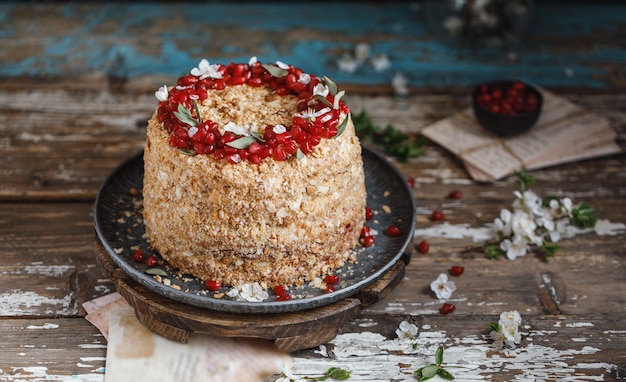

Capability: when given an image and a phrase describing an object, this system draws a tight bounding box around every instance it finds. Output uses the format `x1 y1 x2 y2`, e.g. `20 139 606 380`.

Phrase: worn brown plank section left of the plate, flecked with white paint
0 203 115 318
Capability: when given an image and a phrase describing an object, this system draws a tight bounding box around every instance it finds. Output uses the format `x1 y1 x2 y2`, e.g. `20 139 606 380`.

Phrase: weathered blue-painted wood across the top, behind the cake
0 2 626 89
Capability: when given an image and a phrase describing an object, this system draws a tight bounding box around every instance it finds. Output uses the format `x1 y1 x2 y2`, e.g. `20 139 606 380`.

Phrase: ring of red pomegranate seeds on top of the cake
157 62 350 164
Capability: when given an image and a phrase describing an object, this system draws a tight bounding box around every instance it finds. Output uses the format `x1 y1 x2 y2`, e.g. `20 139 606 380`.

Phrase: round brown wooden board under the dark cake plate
95 237 410 352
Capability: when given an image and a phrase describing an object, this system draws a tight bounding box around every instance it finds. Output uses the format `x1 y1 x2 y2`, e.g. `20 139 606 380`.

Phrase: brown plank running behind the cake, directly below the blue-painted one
0 83 626 201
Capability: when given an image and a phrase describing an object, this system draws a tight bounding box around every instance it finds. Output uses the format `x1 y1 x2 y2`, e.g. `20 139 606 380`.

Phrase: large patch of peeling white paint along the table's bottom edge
284 325 614 381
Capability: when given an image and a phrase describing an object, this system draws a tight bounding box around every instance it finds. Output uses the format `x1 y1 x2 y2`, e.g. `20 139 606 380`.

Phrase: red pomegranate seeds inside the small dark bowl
476 81 539 115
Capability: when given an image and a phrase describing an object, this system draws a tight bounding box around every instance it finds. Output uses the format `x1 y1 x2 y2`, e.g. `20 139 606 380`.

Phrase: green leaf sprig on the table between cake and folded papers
352 110 426 162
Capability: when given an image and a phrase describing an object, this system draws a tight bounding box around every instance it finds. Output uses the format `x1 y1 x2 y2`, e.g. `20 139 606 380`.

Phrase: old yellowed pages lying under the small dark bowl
422 89 621 181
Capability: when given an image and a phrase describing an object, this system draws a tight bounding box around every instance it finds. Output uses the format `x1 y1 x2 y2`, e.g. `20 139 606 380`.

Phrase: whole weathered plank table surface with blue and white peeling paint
0 2 626 381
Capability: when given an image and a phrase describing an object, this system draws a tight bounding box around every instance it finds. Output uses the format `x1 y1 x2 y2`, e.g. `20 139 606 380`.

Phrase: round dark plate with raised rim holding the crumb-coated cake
94 147 415 313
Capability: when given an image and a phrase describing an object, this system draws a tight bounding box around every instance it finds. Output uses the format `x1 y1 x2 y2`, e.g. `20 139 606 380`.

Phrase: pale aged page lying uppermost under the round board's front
104 309 292 382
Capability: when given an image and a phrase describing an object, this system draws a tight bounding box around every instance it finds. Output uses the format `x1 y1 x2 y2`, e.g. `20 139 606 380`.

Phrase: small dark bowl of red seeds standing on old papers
472 80 543 137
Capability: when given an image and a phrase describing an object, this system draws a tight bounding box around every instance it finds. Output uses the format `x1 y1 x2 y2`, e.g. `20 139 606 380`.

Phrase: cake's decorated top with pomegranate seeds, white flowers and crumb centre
154 57 350 164
